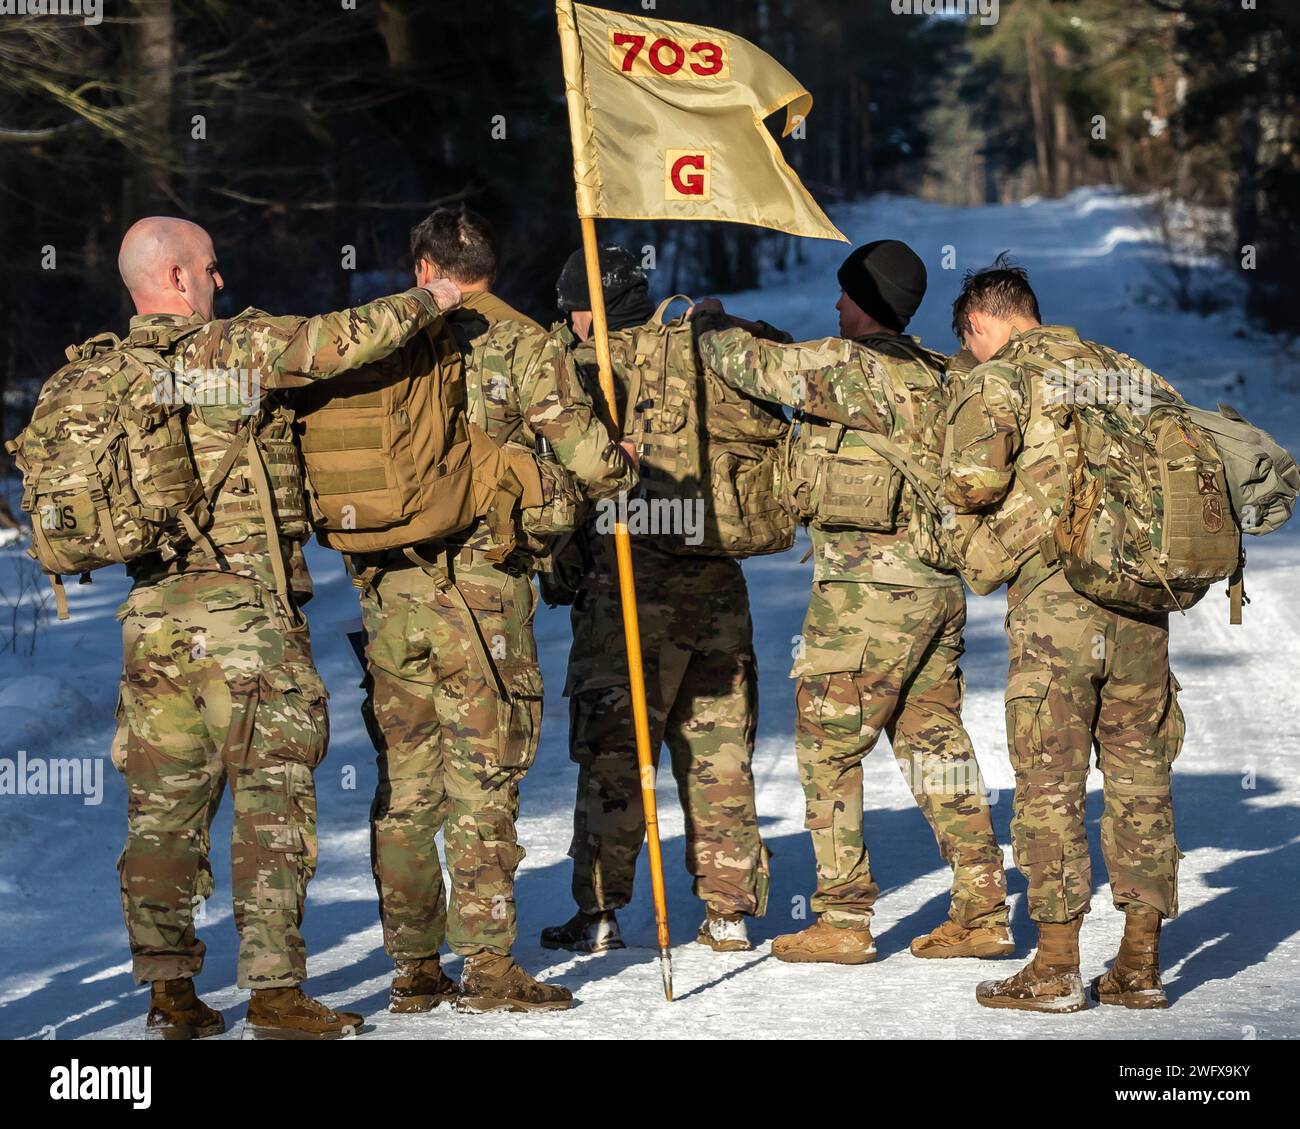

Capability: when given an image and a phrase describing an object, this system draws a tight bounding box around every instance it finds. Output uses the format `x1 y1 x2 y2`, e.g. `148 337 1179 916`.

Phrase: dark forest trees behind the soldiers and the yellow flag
0 0 1300 463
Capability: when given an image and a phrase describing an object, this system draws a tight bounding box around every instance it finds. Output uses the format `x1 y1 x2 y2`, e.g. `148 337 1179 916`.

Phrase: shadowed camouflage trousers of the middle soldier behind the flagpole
566 558 768 916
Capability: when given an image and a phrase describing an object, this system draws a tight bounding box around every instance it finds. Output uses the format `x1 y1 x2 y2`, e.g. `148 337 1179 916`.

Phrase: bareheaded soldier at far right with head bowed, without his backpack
944 257 1183 1012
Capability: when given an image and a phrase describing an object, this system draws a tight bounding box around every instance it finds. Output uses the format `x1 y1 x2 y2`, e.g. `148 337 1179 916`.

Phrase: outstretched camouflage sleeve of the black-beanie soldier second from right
697 313 893 433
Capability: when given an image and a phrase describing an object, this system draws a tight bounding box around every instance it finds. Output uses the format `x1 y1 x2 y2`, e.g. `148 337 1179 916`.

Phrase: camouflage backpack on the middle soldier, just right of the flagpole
611 294 794 558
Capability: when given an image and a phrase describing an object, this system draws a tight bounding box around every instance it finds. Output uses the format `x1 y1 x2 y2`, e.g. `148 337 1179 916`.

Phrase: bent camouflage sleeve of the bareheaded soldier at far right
943 364 1024 514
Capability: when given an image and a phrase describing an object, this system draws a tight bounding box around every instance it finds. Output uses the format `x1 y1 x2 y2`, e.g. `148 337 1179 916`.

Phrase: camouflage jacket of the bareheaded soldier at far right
943 325 1177 604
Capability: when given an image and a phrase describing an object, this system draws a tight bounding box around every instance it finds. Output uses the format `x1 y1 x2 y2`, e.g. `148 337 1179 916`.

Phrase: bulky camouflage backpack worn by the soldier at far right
1054 343 1242 614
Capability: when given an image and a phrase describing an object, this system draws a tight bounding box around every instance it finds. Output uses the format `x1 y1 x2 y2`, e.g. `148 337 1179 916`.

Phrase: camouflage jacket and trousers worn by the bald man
114 290 438 987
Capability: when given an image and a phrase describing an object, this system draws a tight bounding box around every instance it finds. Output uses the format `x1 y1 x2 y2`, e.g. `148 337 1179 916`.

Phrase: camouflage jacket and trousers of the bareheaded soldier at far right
944 326 1183 922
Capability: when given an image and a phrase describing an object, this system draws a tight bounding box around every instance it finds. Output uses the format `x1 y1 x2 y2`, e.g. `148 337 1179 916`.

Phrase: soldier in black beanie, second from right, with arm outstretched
696 241 1013 964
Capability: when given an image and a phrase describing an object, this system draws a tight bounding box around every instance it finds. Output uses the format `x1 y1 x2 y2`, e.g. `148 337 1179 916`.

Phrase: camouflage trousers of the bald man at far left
113 572 329 989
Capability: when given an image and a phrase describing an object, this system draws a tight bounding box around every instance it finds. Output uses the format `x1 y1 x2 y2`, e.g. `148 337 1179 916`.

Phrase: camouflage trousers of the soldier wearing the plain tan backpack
361 550 542 960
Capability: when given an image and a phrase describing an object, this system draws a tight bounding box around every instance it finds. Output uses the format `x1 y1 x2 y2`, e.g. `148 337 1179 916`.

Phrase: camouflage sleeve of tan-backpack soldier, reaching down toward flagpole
511 330 637 498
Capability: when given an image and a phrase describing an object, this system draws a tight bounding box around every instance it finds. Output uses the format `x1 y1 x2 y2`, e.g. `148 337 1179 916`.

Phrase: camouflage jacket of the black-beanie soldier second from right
697 313 961 588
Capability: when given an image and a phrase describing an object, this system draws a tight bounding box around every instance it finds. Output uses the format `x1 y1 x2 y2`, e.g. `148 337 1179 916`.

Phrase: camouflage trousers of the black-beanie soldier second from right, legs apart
794 581 1008 927
